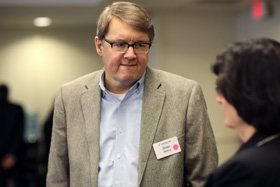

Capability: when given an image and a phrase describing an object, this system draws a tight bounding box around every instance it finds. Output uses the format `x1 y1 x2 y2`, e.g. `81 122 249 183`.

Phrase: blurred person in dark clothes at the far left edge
0 85 24 187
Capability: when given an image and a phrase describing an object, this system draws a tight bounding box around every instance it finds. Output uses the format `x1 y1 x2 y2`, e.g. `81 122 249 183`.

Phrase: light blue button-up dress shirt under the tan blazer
98 72 146 187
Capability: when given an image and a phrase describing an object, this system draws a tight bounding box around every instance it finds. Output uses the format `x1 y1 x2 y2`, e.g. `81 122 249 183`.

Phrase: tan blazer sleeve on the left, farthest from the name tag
46 87 69 187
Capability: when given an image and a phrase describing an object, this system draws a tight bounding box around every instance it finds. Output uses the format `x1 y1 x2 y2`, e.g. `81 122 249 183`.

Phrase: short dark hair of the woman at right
212 38 280 134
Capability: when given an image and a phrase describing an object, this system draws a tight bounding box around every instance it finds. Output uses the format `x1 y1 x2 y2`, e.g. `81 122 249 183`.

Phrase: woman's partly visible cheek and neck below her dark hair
216 94 247 129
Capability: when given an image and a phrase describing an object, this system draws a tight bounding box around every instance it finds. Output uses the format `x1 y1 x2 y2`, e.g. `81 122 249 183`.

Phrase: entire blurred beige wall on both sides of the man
0 1 280 163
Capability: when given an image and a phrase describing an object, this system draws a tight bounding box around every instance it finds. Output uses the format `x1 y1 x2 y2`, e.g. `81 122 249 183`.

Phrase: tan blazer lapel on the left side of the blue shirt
81 74 101 186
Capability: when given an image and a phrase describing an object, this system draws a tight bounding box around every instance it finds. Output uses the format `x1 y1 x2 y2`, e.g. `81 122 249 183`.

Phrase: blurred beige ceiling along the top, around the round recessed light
0 0 253 28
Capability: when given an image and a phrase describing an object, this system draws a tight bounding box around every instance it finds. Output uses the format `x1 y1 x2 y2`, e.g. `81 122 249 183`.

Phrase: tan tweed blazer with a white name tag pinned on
47 67 218 187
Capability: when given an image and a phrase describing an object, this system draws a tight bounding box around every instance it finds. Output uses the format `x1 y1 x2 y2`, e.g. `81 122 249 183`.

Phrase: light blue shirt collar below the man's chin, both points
99 68 147 97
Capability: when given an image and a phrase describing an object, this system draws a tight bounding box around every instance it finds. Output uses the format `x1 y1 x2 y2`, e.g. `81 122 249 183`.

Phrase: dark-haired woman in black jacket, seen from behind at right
205 39 280 187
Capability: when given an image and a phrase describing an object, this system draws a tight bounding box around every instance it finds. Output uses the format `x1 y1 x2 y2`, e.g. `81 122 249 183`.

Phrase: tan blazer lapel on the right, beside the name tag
138 68 165 186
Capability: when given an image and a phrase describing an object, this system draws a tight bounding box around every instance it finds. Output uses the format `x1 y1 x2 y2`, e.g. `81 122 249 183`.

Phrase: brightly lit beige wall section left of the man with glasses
0 29 102 127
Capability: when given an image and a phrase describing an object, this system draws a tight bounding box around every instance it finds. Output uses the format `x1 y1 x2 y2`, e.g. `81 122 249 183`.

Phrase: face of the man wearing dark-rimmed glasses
95 17 150 93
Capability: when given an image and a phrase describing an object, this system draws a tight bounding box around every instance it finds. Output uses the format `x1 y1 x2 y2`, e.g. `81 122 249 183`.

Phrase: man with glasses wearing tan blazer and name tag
47 2 217 187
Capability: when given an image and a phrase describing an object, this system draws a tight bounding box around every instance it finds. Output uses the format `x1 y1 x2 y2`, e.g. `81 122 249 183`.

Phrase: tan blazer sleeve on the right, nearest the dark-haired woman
185 84 218 186
